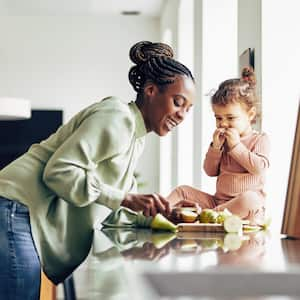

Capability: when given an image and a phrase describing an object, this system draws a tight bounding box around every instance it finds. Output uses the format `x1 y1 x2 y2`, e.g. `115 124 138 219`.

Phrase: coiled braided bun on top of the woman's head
129 41 174 65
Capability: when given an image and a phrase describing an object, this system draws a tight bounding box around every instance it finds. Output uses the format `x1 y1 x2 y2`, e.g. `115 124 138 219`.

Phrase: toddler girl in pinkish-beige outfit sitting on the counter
168 68 269 225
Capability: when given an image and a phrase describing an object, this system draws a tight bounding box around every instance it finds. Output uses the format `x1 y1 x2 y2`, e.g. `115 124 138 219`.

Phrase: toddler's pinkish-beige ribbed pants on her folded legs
167 185 265 225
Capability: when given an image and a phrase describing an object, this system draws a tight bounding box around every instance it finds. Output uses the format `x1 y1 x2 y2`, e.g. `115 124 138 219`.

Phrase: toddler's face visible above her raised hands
212 102 256 136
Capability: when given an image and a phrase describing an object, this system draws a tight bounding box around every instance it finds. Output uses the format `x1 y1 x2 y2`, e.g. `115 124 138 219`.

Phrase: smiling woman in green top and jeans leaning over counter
0 42 195 299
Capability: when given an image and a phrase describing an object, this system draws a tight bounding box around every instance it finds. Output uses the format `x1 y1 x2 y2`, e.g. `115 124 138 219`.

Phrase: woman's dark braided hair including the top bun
128 41 194 94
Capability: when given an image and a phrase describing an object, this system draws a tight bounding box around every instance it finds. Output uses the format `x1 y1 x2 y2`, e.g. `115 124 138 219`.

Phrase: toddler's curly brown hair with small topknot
211 67 258 123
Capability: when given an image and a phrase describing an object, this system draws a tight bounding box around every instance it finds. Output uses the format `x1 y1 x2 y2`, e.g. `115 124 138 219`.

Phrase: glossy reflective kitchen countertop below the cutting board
73 229 300 300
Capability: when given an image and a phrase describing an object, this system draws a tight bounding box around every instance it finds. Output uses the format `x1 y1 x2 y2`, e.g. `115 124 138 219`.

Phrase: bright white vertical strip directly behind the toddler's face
200 0 238 194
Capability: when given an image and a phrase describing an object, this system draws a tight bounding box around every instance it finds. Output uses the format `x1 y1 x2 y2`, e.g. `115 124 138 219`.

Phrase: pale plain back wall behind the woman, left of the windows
0 16 160 191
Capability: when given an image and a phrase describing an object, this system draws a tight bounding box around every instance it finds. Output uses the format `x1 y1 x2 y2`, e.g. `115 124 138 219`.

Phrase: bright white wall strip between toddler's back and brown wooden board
262 0 300 232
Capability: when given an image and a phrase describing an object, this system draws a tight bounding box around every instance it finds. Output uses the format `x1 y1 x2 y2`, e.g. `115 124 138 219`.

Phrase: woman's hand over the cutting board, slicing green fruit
121 193 171 217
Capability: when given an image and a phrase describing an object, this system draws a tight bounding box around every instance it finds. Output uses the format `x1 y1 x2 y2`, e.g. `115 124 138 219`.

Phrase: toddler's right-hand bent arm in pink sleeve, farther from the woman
228 134 270 175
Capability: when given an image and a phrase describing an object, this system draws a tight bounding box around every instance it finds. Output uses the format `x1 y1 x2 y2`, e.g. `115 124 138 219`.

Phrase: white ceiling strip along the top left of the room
0 0 166 17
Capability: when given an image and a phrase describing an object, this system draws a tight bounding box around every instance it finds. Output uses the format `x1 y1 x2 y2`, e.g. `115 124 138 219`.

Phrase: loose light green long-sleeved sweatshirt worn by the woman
0 97 146 282
